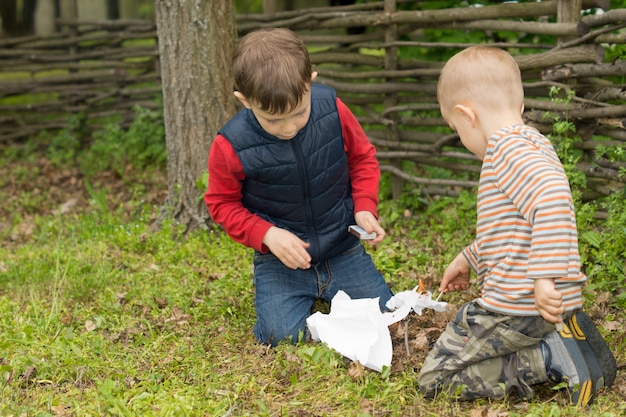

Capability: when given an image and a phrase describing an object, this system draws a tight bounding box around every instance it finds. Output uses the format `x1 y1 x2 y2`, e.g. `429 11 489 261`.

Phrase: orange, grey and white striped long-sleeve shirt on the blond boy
463 125 587 316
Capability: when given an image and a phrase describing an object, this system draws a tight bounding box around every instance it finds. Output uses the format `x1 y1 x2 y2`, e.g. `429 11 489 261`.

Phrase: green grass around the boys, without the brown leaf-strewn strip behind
0 197 624 416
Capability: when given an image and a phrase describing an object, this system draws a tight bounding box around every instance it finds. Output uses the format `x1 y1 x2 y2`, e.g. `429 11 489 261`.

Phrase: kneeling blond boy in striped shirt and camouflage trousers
418 46 616 406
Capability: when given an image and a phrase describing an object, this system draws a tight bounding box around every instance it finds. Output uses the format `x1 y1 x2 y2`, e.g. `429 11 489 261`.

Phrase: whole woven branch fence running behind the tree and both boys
0 0 626 199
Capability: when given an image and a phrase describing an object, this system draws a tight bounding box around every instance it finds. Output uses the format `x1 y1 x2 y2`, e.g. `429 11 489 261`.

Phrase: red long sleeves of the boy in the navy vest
204 98 380 253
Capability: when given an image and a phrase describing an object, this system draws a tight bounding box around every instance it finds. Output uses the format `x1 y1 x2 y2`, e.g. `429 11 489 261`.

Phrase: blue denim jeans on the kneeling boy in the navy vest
254 243 393 346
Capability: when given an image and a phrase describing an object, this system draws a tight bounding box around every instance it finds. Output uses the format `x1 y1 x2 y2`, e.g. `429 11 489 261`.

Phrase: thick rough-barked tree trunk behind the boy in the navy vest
155 0 236 231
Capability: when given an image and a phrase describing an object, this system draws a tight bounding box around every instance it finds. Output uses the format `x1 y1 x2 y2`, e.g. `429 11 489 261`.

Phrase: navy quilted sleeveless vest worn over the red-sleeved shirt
219 84 357 262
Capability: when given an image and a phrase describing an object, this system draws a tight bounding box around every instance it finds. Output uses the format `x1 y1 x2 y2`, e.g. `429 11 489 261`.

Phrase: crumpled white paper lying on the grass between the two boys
307 290 446 372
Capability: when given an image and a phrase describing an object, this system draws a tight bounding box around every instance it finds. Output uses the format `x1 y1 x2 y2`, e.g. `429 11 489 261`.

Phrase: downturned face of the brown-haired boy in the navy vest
235 88 311 140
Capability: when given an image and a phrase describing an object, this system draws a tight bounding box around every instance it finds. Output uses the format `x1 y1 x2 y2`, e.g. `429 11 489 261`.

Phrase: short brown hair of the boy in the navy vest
233 28 313 114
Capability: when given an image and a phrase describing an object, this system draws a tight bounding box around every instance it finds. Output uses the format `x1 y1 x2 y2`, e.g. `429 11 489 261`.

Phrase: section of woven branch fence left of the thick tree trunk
0 20 161 140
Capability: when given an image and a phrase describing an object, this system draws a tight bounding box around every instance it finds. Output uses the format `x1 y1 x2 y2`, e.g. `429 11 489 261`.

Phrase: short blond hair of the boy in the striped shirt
437 46 524 114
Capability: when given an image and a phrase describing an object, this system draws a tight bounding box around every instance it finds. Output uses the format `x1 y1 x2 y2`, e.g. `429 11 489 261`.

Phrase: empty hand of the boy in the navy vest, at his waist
263 226 311 269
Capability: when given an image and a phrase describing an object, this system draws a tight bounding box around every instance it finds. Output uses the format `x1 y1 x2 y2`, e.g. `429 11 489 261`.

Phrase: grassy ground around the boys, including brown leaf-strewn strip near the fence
0 154 626 416
